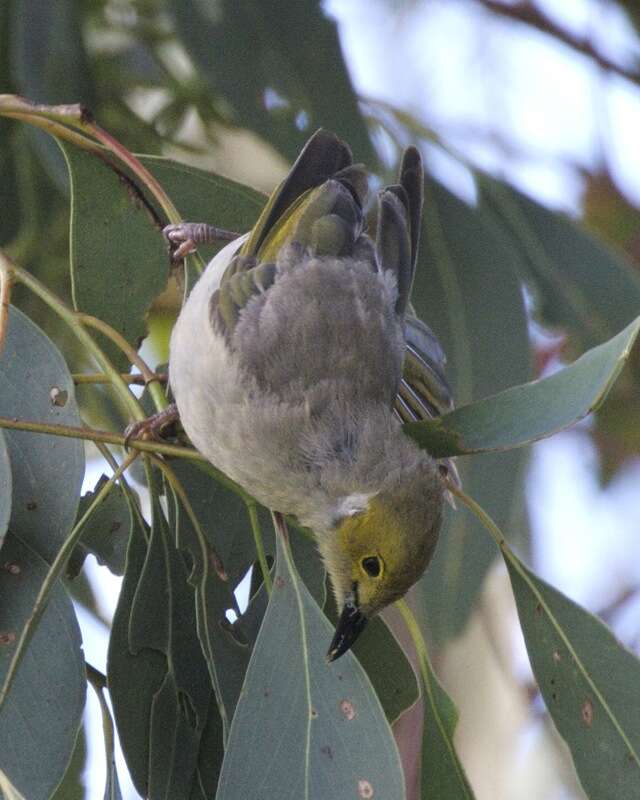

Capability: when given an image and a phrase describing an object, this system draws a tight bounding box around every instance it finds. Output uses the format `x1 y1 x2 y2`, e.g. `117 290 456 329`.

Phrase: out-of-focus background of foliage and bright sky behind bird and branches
0 0 640 800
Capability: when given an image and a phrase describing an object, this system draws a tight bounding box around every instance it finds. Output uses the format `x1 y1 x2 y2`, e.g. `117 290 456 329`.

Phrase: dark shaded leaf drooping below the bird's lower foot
109 488 212 800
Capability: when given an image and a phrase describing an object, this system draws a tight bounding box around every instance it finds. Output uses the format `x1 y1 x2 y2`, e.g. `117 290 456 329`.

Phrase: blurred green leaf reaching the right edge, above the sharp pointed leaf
479 177 640 347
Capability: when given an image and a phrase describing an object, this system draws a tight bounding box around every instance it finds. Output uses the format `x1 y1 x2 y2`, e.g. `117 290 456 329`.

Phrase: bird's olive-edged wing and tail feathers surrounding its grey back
210 130 453 421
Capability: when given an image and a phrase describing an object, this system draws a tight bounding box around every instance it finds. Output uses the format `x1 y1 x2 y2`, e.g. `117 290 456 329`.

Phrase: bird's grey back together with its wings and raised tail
209 130 452 432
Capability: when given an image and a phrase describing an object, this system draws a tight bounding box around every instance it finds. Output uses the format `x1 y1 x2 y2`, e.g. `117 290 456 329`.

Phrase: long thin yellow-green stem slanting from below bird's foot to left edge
0 453 138 707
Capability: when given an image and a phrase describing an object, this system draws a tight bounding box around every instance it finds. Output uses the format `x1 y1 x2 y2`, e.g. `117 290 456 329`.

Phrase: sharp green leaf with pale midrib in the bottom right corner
503 547 640 800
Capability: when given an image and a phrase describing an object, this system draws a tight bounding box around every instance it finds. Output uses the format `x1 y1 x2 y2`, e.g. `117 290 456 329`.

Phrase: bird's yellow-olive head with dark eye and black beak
320 457 443 661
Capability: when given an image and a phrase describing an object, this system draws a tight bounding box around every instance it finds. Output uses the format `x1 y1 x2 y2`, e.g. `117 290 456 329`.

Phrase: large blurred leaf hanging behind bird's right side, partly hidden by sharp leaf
411 180 531 642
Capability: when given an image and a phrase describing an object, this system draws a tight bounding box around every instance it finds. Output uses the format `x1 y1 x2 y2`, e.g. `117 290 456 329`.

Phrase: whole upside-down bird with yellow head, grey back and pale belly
168 131 451 660
